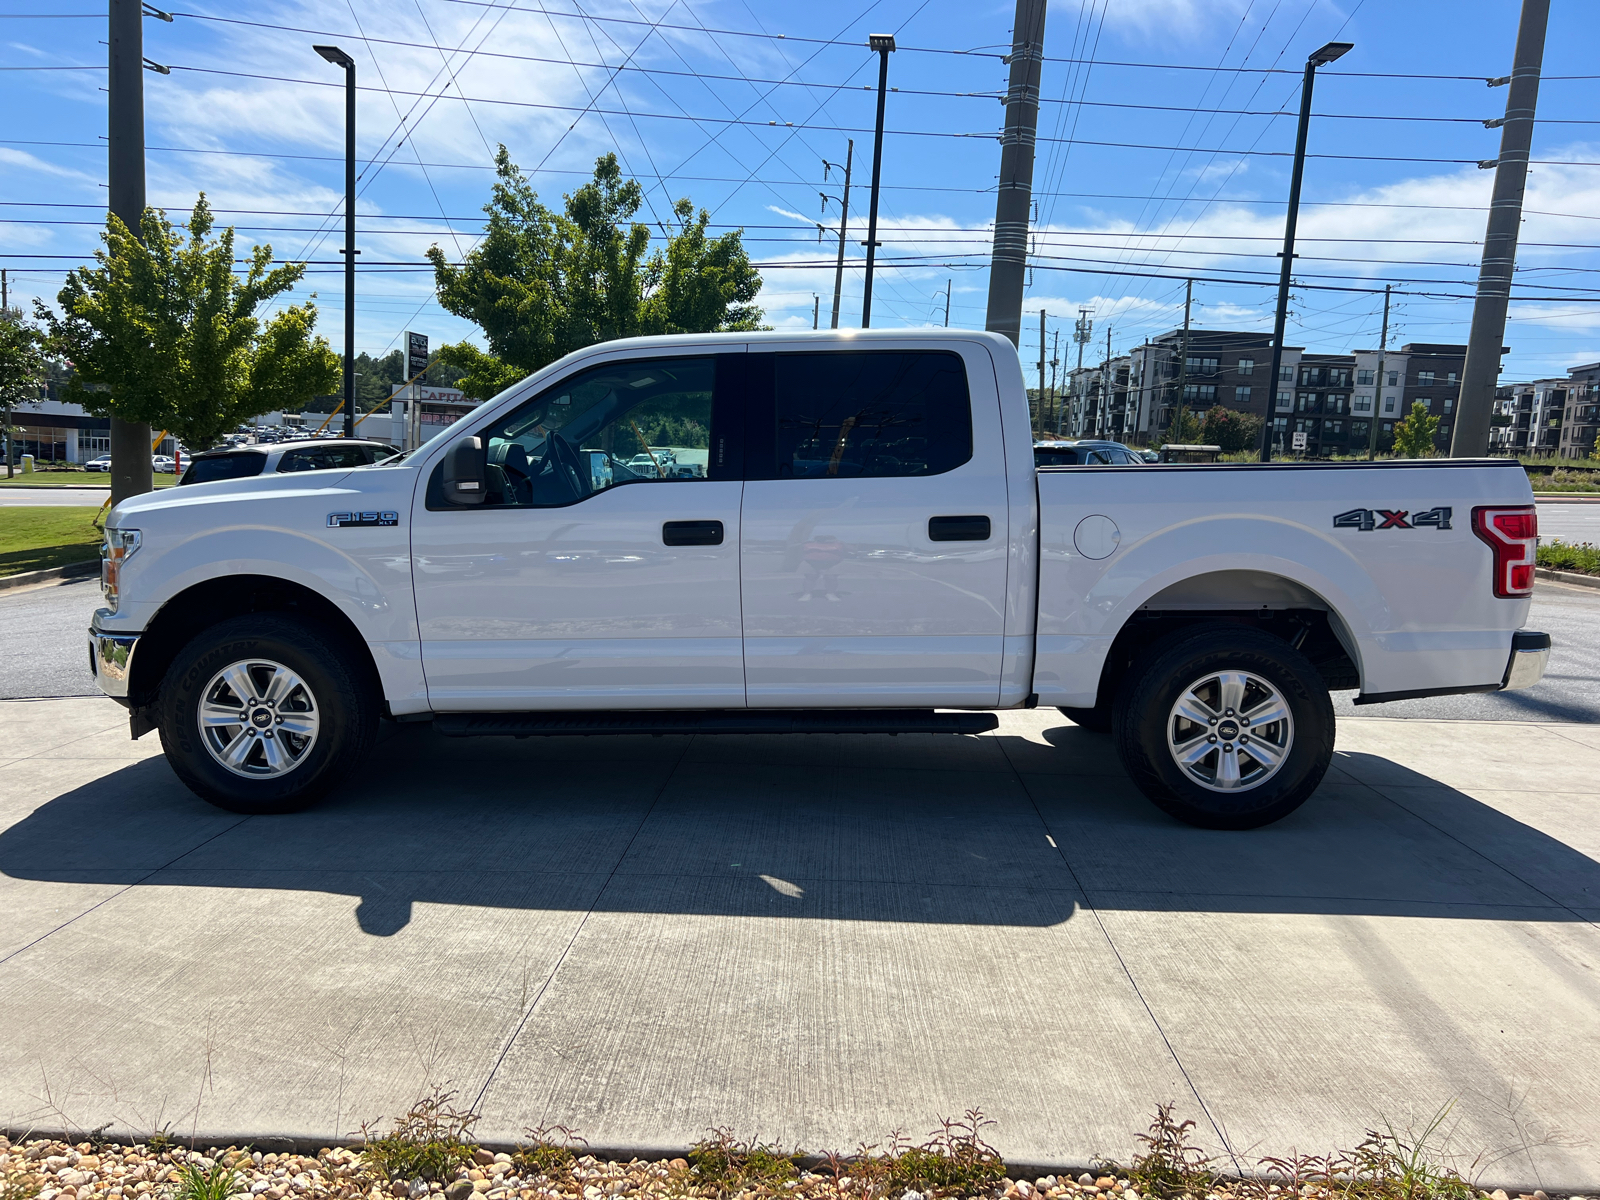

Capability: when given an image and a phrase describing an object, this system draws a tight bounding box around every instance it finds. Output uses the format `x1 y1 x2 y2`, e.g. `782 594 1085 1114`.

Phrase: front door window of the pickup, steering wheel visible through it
451 357 717 509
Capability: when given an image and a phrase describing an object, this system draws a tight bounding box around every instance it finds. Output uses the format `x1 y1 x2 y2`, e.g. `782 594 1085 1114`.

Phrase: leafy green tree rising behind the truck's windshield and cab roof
427 146 762 397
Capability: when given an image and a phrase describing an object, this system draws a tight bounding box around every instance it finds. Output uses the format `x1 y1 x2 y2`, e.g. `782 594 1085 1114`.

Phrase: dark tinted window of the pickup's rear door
746 350 973 478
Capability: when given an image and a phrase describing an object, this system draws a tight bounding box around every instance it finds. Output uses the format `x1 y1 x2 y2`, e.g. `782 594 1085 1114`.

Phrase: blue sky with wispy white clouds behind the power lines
0 0 1600 379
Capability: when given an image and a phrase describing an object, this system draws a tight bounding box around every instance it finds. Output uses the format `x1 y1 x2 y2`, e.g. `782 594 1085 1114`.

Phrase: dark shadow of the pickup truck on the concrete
0 725 1600 936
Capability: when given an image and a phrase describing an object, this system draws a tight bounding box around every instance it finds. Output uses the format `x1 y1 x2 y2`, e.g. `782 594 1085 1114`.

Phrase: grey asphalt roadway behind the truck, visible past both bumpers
0 576 1600 723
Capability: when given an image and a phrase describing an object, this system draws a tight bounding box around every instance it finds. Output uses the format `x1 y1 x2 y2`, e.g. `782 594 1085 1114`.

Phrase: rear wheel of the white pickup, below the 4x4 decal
1114 624 1334 829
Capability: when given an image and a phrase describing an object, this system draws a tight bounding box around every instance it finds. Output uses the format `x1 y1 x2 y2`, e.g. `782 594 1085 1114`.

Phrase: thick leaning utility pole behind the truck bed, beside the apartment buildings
1450 0 1550 458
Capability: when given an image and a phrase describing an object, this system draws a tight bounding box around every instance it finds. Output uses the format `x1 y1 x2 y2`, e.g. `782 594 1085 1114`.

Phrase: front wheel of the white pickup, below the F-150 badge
158 614 379 816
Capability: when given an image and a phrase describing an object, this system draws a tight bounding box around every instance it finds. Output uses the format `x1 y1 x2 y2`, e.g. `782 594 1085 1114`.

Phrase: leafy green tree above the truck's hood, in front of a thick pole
37 192 339 450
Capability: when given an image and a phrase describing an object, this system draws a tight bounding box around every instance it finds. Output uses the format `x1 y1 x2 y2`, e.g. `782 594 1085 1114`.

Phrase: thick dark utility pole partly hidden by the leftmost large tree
106 0 155 507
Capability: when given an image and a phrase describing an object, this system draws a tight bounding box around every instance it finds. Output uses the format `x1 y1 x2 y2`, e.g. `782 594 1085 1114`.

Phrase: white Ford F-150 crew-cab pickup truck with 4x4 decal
90 330 1550 829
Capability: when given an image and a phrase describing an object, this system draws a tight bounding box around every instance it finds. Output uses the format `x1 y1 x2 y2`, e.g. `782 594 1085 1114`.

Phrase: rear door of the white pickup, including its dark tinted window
739 342 1008 707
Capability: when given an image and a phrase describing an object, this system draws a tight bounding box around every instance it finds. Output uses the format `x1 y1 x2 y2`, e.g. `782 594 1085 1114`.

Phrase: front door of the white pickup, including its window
411 352 744 712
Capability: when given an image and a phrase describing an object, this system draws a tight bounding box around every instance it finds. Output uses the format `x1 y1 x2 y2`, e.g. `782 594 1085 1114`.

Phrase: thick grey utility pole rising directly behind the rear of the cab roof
984 0 1045 347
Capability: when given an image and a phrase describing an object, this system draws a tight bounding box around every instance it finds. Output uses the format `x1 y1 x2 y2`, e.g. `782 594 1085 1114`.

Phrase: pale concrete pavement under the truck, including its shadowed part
0 699 1600 1192
